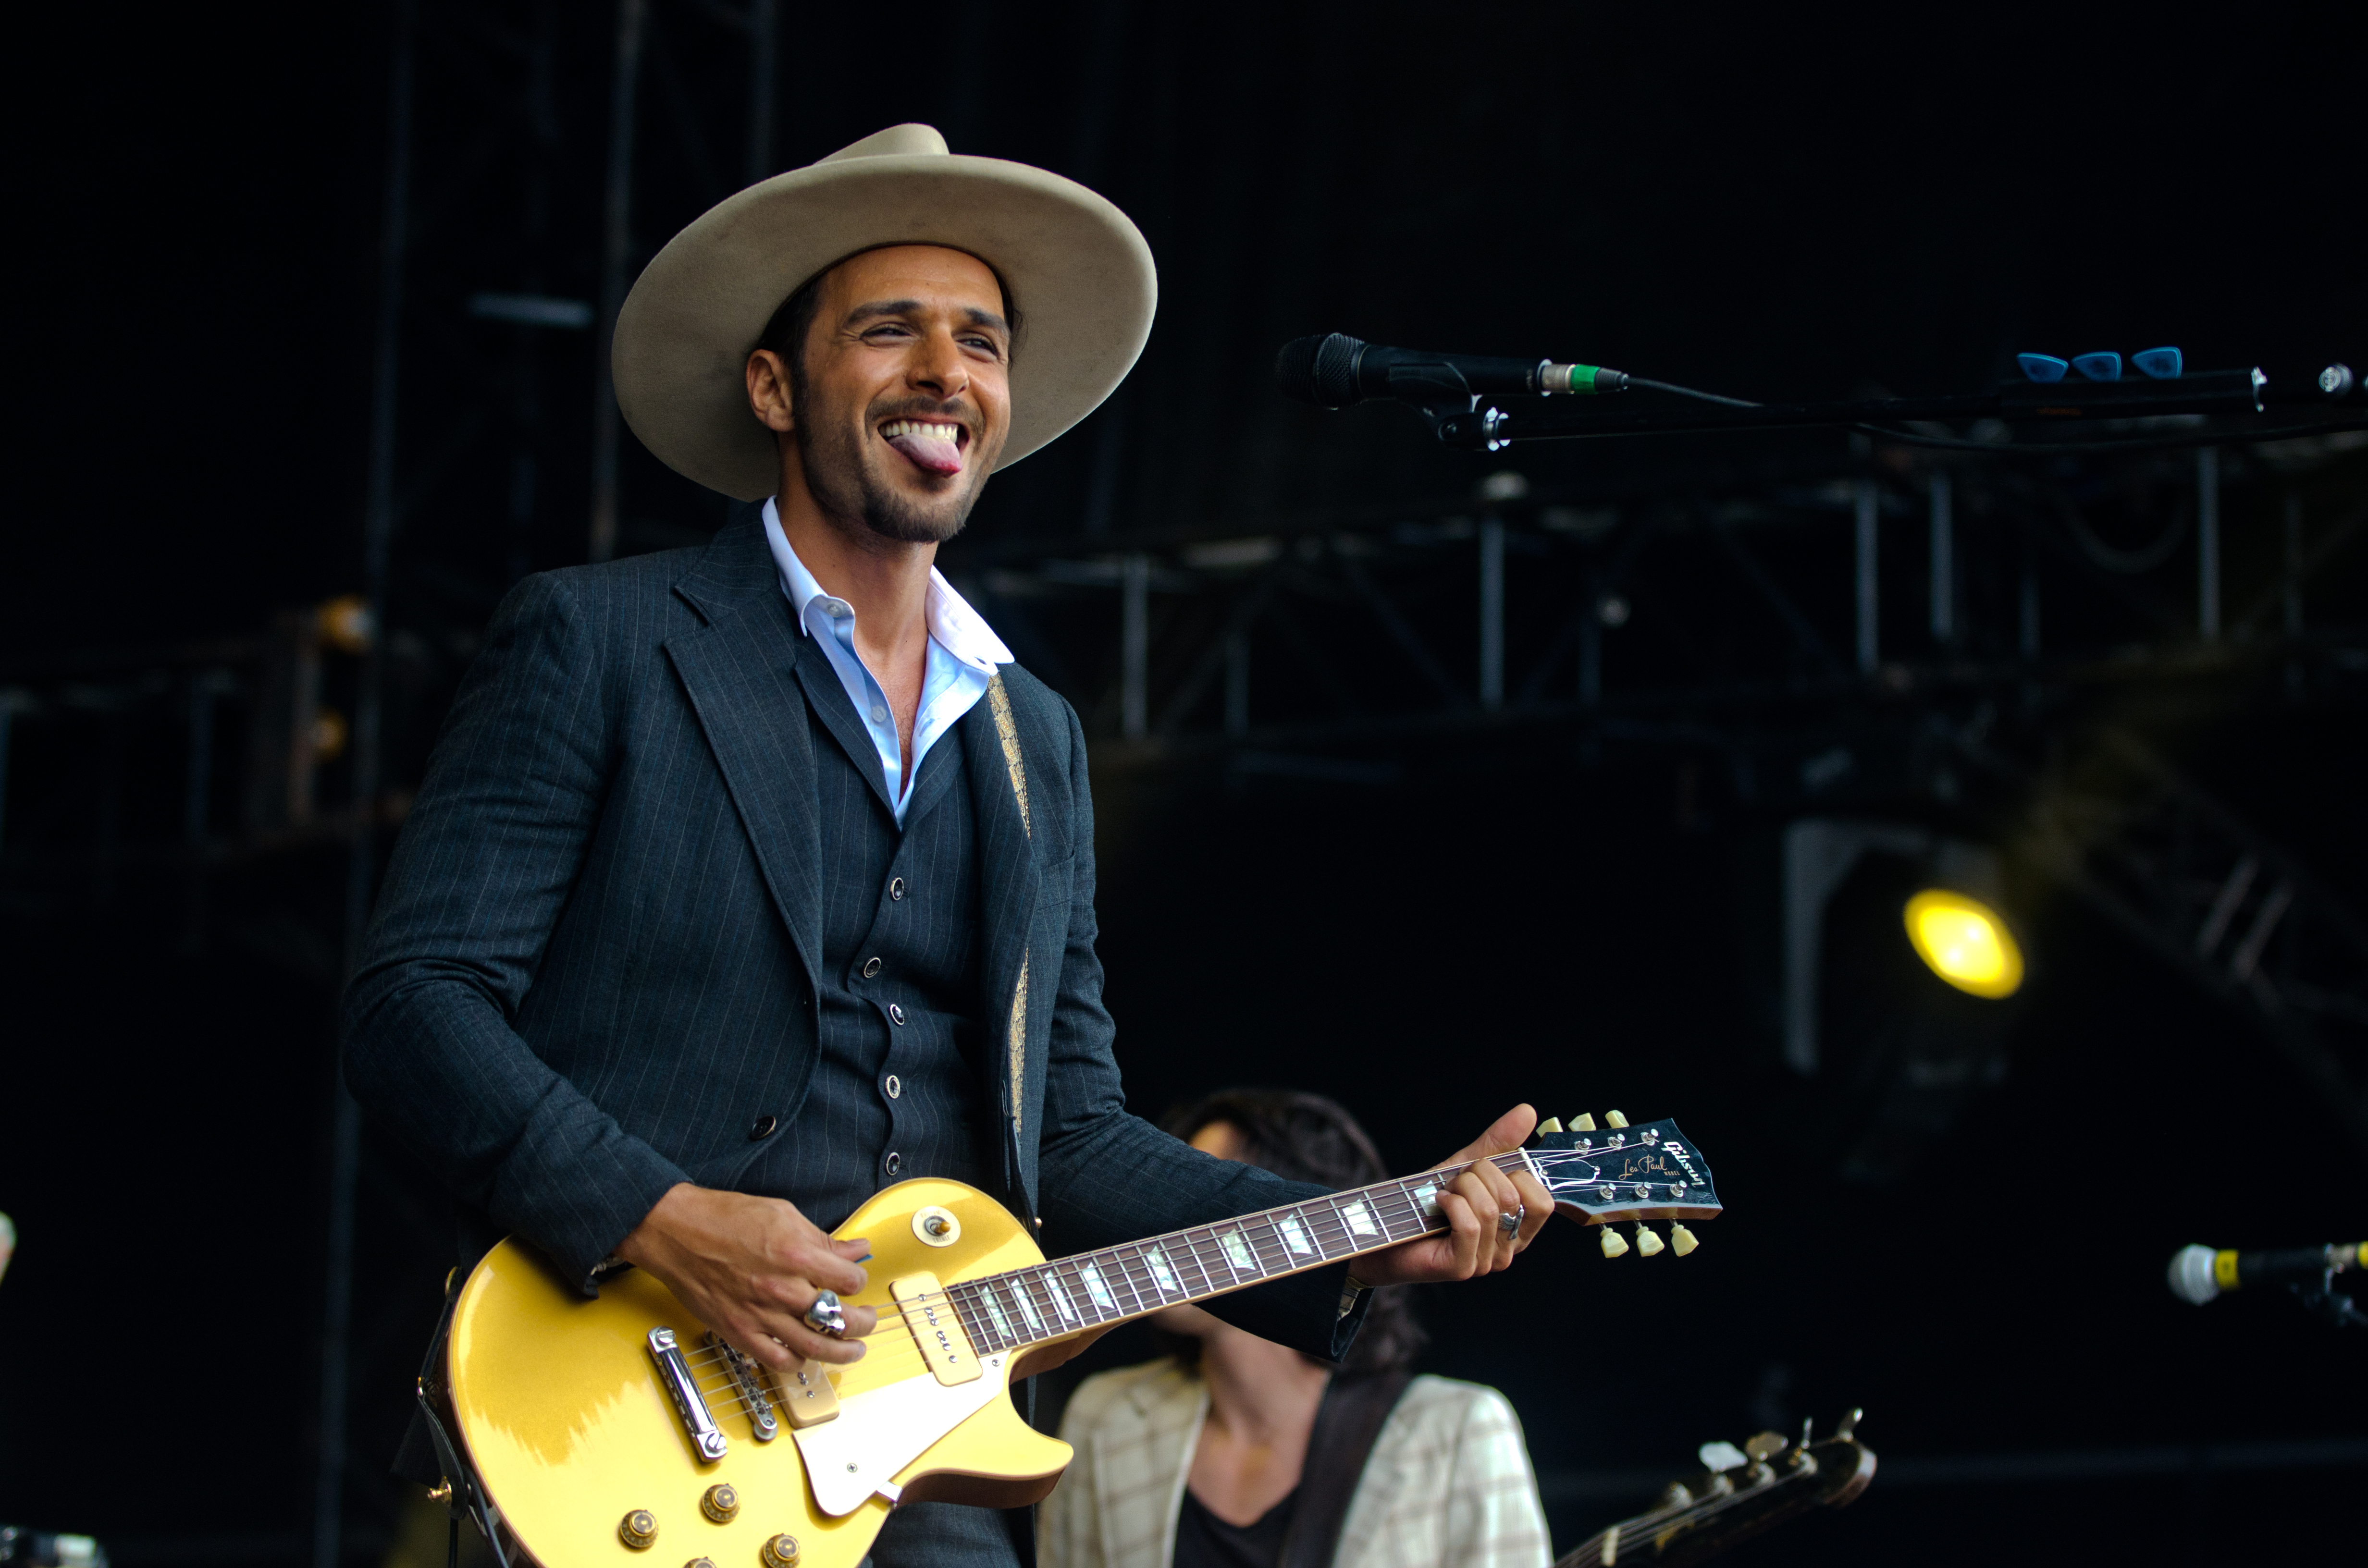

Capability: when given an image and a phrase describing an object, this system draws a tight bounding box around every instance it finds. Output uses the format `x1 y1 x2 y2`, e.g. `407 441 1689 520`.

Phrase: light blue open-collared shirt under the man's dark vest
765 500 1011 827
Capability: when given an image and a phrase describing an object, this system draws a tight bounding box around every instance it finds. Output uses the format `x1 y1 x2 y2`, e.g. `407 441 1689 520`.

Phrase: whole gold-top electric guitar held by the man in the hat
419 1118 1719 1568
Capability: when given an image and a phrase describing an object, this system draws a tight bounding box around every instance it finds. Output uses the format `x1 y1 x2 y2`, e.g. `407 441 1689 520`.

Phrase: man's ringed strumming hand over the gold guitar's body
616 1182 876 1372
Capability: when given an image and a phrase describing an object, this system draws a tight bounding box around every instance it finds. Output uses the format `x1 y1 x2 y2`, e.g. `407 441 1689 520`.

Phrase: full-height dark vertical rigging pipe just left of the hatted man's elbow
312 0 419 1568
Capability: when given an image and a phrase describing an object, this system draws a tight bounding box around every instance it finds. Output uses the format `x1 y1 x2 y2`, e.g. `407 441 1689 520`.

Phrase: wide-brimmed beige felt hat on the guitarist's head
608 125 1158 500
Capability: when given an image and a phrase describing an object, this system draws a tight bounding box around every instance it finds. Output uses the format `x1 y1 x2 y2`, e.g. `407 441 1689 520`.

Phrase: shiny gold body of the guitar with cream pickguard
447 1179 1070 1568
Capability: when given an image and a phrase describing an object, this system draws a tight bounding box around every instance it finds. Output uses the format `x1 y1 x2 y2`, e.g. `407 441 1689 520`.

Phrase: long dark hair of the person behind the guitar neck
1158 1090 1431 1374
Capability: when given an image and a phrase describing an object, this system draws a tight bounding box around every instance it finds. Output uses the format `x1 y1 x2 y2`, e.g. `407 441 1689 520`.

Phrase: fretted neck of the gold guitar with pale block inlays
945 1149 1534 1355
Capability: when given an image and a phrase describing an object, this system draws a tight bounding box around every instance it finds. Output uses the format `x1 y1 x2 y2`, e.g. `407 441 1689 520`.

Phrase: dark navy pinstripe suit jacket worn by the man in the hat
345 521 1362 1355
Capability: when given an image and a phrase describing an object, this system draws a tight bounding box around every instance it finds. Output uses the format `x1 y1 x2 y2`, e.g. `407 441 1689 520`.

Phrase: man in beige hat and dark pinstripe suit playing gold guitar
345 125 1551 1568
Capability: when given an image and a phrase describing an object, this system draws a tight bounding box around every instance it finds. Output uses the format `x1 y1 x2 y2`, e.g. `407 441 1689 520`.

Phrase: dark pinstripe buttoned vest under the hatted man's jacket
739 649 1002 1229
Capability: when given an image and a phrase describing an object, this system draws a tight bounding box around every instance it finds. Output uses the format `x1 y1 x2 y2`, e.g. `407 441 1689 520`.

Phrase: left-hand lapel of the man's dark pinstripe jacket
666 521 822 985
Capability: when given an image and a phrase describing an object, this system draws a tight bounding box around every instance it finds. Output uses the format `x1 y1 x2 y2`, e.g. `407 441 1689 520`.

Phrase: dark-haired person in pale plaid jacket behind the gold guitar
1037 1090 1554 1568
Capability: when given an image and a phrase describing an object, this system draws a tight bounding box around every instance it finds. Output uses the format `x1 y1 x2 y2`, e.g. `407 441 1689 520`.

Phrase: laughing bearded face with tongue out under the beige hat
791 244 1011 545
